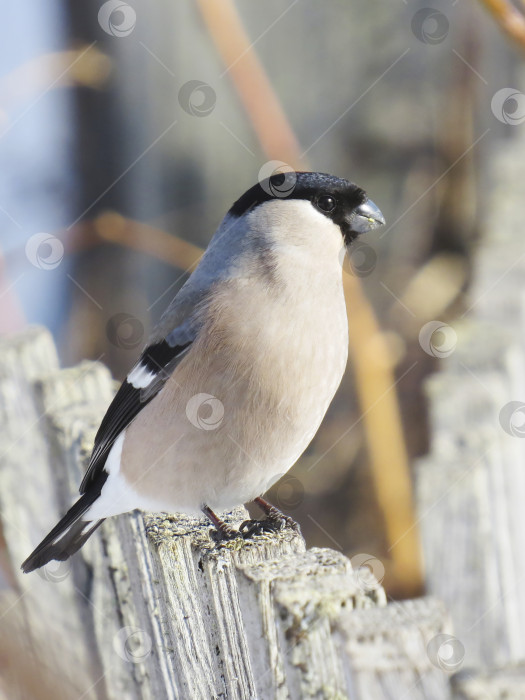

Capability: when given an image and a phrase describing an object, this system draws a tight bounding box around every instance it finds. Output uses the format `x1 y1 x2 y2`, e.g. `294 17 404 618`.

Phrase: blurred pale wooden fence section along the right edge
416 127 525 698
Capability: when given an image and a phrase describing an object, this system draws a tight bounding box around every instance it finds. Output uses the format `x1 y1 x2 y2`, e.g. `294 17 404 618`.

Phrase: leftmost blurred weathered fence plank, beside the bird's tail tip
0 329 104 698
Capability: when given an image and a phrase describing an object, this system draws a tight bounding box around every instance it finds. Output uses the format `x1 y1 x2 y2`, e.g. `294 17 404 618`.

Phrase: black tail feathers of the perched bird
22 474 107 574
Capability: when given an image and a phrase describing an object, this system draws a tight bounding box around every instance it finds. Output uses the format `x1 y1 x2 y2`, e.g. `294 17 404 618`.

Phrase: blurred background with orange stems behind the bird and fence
0 0 525 597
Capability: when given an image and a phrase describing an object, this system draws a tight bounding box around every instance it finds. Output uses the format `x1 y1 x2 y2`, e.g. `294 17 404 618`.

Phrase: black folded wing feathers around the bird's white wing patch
80 340 191 494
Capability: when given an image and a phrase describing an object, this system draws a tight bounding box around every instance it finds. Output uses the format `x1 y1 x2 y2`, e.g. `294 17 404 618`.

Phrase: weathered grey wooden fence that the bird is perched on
0 328 450 700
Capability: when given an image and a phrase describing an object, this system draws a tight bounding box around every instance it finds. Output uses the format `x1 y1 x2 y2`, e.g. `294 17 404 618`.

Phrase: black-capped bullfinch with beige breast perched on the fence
22 170 385 573
